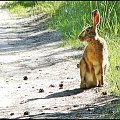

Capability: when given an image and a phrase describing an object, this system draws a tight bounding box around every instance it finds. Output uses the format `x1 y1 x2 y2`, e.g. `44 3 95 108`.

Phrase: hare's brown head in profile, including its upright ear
78 10 100 41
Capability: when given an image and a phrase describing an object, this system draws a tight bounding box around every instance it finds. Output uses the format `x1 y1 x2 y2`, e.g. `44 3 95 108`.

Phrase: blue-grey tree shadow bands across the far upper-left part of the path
0 14 61 52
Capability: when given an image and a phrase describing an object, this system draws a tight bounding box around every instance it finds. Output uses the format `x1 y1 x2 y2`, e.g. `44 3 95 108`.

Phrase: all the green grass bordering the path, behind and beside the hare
3 1 120 95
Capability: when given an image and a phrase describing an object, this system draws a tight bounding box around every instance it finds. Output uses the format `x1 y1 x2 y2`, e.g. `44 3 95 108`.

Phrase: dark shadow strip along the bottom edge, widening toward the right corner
17 97 120 119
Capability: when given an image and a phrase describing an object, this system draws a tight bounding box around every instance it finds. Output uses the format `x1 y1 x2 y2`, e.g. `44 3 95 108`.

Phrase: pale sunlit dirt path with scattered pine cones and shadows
0 7 119 119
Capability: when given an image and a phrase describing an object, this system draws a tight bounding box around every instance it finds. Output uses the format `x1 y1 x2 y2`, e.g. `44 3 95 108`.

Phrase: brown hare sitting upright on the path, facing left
77 10 108 88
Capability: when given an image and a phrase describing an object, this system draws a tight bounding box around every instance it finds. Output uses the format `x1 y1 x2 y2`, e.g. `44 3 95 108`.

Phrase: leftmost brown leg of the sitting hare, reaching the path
79 58 86 88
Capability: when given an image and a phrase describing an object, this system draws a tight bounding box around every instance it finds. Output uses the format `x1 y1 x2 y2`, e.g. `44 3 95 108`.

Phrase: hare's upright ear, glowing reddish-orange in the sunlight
92 10 100 28
